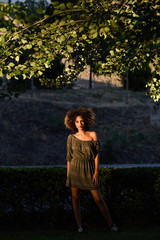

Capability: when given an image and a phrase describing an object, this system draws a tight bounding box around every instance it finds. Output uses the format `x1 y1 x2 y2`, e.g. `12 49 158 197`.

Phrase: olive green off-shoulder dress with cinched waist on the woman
66 134 99 190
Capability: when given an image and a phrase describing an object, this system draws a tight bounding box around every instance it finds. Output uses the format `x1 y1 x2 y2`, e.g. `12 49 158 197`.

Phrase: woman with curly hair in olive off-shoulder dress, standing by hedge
64 107 118 233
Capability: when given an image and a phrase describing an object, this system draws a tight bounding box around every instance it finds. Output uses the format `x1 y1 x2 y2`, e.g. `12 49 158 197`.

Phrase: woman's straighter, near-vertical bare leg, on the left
71 188 82 227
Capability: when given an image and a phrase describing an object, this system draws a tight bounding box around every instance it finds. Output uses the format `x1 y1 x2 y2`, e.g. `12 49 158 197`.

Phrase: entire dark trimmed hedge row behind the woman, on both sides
0 167 160 227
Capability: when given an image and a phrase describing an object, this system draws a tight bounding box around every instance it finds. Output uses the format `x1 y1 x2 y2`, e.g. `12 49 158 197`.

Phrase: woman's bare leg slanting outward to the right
90 190 113 227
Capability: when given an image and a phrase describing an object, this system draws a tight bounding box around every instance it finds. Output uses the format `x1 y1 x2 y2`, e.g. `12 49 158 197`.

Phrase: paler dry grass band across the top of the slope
20 85 150 107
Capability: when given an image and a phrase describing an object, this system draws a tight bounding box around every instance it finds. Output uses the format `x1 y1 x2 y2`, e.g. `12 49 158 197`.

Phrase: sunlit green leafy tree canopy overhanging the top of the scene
0 0 160 101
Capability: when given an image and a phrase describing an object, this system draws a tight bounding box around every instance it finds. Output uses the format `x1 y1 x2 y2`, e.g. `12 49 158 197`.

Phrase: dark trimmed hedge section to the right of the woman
101 168 160 224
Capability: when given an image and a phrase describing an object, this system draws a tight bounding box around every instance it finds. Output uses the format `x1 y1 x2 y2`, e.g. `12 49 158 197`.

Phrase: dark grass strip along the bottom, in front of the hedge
0 227 160 240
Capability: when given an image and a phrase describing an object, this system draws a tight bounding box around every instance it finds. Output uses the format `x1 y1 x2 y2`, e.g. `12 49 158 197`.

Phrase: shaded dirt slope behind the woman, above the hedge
0 83 160 166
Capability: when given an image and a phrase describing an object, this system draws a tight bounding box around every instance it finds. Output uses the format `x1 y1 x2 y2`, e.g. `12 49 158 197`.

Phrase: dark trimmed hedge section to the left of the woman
0 167 70 229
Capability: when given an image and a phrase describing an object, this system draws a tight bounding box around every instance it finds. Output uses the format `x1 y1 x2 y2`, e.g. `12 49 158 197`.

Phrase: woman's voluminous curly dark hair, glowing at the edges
64 107 95 132
